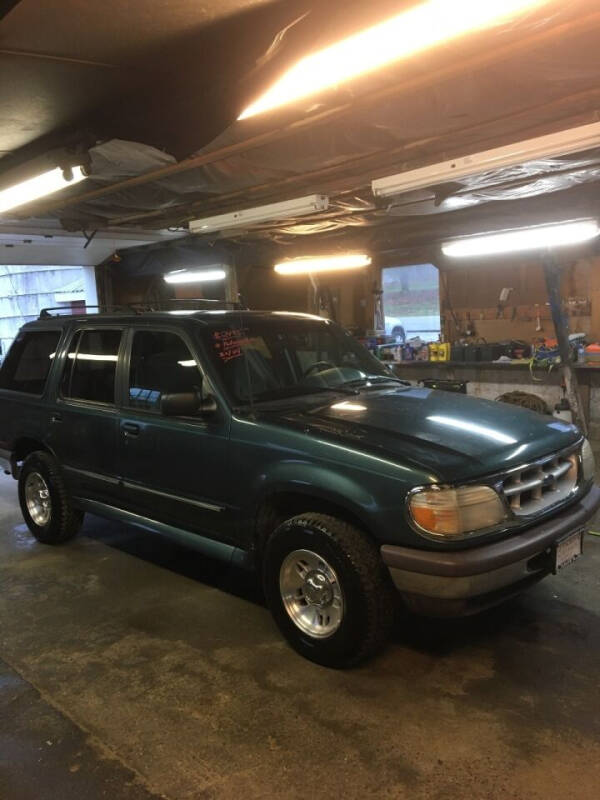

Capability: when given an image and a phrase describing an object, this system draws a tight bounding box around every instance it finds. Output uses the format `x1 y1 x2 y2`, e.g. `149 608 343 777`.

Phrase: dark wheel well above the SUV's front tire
254 492 371 560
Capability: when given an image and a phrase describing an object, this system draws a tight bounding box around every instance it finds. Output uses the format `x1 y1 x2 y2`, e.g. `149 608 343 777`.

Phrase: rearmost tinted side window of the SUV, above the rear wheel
0 331 61 395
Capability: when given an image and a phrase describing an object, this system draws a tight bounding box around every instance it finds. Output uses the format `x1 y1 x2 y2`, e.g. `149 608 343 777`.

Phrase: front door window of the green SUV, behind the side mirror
128 331 202 411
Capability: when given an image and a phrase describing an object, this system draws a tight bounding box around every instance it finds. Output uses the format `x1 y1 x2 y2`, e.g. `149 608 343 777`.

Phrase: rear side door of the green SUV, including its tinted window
47 327 123 505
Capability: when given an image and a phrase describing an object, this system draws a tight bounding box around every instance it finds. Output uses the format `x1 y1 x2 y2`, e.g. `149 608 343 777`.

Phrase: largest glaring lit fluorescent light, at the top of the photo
238 0 548 119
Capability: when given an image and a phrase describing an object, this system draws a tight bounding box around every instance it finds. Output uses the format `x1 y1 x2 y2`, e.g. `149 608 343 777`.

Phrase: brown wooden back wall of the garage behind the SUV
103 248 600 341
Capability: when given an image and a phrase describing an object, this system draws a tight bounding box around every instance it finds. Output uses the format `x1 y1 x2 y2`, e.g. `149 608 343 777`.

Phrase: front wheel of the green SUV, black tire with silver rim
263 513 395 668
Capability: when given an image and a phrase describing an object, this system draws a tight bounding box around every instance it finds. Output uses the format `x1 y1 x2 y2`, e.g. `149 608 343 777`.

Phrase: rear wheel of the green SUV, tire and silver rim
19 450 84 544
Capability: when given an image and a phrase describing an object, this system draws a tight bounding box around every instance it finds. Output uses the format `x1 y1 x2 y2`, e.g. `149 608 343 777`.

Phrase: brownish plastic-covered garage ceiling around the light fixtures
0 0 600 264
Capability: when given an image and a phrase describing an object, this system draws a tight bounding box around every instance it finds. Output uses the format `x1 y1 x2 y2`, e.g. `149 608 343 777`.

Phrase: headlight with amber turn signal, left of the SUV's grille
409 486 506 539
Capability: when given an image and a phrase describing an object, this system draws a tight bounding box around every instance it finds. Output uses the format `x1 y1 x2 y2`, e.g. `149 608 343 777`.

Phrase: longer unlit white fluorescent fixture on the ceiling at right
371 122 600 197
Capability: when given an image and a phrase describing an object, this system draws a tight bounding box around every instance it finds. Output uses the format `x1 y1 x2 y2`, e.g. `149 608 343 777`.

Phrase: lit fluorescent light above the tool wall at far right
442 219 600 258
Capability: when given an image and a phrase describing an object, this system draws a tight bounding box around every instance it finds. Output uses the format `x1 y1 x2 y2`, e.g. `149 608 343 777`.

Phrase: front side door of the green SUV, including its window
119 327 235 542
